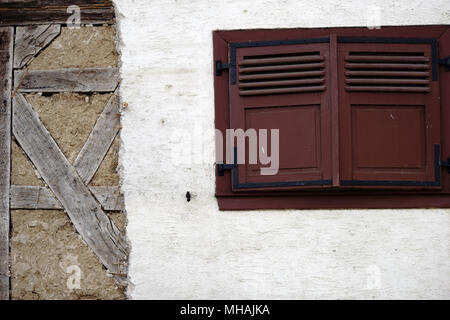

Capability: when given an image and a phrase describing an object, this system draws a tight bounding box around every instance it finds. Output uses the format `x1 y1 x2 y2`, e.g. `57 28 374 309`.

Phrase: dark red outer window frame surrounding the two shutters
213 25 450 210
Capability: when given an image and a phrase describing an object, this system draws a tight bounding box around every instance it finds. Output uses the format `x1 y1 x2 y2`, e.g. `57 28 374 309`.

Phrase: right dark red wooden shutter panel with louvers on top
338 38 440 188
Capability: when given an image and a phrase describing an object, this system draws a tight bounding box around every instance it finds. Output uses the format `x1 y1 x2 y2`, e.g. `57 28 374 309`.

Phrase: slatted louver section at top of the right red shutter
345 52 430 92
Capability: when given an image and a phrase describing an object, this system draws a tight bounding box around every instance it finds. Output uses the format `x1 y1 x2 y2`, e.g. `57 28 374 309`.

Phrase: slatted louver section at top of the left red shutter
239 52 325 96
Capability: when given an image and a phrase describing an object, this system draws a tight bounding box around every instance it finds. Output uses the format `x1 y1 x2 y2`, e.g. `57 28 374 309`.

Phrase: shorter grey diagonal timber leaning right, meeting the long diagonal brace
74 94 120 184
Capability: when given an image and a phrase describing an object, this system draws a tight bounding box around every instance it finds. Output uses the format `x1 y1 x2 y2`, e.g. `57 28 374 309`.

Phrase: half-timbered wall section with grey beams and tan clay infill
0 0 129 299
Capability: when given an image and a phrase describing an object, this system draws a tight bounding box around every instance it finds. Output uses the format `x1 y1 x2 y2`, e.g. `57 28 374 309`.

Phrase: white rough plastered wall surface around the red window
115 0 450 299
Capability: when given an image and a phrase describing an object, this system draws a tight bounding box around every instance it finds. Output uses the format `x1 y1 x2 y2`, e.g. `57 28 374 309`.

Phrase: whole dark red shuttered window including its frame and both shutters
213 26 450 210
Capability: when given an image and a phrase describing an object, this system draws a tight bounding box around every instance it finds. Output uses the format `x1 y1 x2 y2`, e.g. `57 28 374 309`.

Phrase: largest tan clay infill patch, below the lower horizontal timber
11 210 124 300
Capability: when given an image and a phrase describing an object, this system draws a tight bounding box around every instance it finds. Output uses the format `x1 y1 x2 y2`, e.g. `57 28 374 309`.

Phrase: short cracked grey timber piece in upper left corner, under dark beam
14 24 61 69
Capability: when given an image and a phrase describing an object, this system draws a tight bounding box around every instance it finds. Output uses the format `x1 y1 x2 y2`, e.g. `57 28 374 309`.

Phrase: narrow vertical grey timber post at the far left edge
0 28 14 300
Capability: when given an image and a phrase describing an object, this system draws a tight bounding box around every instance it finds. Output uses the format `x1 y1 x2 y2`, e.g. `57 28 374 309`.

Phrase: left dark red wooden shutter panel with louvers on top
229 38 331 191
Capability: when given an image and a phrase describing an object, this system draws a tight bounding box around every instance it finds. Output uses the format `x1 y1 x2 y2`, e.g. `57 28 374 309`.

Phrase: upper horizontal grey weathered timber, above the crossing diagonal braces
14 68 119 92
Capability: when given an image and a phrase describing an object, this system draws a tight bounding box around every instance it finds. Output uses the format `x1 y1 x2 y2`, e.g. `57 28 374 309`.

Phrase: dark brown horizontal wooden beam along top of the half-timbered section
0 0 114 26
